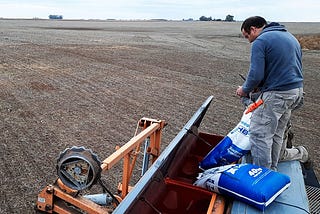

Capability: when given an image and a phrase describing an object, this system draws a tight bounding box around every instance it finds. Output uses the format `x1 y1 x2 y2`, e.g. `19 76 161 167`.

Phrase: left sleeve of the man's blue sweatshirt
242 38 265 93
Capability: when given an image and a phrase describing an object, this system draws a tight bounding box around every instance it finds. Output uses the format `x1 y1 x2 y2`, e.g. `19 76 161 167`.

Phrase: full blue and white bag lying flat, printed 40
194 164 290 210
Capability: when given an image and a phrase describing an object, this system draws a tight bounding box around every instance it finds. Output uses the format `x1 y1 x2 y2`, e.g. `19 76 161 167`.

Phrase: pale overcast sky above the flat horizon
0 0 320 22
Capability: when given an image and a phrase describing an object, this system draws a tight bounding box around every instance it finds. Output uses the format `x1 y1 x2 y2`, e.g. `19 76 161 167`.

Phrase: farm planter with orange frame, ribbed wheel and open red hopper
36 96 320 214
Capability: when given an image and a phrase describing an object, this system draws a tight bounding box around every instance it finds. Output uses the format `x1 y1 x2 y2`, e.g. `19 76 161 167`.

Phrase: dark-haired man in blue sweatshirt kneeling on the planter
236 16 309 170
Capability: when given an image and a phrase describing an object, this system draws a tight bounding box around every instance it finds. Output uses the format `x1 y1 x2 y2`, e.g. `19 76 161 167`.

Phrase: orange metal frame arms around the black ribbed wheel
36 118 166 213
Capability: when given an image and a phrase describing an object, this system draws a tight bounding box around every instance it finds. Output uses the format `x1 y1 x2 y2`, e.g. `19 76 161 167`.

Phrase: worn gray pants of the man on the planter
250 88 303 170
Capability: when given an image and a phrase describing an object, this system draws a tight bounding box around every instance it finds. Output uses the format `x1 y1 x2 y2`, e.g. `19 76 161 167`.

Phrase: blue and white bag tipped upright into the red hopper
199 112 252 170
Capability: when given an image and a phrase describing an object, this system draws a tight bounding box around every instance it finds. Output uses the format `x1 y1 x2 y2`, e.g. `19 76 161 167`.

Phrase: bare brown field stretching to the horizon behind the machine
0 20 320 213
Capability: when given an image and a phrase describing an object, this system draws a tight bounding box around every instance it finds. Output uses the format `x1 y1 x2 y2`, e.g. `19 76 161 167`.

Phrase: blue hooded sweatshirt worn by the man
242 22 303 93
